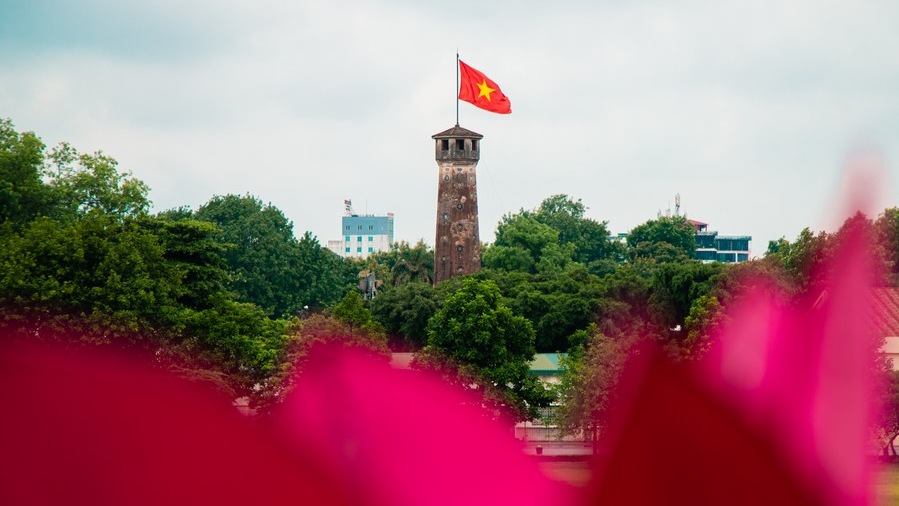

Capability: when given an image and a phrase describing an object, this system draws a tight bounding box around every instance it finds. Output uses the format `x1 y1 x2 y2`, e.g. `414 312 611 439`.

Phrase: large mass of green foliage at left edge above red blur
0 121 296 393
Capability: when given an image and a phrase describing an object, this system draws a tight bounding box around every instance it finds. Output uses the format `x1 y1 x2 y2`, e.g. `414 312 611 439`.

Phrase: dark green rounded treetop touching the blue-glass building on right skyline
627 216 696 263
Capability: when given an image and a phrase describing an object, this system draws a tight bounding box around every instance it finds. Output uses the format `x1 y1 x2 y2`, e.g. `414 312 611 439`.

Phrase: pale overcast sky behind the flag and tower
0 0 899 255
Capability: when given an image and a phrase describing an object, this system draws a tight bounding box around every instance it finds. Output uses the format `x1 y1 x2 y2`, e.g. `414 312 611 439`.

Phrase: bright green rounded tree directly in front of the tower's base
416 278 552 421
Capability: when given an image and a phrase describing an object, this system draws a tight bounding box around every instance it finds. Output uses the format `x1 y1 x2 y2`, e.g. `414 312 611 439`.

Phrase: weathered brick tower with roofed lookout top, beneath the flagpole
431 125 484 285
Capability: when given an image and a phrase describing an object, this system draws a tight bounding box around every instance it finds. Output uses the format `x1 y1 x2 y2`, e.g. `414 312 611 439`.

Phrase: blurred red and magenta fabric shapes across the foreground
0 218 884 506
